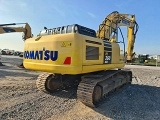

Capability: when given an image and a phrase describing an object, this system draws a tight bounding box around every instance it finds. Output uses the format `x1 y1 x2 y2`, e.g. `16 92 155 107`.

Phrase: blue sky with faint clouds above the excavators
0 0 160 54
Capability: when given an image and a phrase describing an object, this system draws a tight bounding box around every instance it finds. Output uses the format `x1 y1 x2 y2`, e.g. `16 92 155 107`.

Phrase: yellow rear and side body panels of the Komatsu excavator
24 33 124 74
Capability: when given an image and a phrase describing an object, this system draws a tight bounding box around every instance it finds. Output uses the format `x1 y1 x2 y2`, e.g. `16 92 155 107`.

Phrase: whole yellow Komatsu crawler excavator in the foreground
24 12 138 107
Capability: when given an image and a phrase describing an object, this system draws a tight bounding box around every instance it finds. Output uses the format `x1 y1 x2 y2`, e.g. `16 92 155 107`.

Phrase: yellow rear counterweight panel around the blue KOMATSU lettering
24 33 82 73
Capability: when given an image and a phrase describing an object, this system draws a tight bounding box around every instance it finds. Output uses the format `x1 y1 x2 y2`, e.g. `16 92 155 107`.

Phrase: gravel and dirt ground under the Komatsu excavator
0 56 160 120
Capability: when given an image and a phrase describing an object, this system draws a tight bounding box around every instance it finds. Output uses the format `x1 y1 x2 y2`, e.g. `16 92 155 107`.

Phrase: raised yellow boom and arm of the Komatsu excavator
97 11 138 62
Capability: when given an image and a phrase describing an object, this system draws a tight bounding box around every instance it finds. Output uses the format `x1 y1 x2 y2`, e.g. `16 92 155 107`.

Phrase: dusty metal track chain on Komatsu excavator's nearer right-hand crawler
77 71 131 107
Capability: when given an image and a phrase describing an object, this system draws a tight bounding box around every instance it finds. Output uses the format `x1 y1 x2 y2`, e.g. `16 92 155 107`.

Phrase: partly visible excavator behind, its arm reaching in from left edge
0 23 32 68
